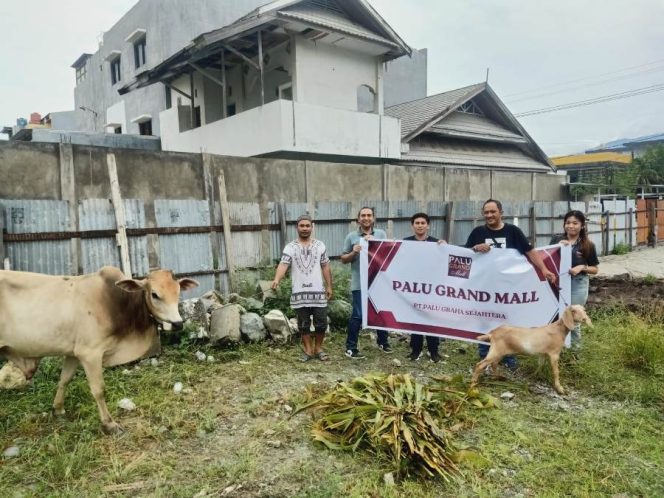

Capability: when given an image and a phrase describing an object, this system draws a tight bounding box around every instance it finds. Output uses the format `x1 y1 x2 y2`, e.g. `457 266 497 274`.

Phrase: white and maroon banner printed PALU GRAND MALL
360 240 572 342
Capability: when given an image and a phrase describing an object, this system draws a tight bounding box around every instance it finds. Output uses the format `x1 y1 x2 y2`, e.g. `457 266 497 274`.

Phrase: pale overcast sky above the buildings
0 0 664 156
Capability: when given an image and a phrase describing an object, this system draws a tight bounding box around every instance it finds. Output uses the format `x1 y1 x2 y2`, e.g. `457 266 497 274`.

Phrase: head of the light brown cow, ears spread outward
115 270 198 330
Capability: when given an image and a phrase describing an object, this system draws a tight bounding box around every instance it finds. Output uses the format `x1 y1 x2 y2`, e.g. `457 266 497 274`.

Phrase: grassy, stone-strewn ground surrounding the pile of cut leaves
0 307 664 498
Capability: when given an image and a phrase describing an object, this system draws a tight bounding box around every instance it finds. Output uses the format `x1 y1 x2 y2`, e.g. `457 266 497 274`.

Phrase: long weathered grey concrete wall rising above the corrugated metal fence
0 142 566 203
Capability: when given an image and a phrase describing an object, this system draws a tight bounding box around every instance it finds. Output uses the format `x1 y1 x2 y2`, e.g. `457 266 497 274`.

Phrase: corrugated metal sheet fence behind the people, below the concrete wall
0 199 648 295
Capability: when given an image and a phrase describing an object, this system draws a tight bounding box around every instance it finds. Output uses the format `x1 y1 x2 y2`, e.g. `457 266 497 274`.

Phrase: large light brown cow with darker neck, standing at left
0 266 198 433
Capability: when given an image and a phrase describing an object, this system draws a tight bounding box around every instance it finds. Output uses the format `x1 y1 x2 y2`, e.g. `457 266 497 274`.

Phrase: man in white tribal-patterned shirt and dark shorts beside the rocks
272 214 332 361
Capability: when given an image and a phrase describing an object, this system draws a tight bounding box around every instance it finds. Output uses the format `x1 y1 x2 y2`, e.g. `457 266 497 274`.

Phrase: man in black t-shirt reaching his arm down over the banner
466 199 556 369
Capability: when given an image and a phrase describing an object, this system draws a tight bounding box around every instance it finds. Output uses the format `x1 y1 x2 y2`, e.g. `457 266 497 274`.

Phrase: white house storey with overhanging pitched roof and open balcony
119 0 411 160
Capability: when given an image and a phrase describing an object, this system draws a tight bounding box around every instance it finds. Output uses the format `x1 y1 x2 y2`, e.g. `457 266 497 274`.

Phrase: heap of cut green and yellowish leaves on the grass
296 374 495 480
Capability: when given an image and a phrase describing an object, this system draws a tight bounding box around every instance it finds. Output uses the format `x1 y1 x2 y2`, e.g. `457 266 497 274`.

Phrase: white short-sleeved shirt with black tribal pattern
281 239 330 309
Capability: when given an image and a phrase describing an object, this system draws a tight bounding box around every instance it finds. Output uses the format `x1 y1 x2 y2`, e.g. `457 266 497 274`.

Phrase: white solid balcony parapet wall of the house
160 100 401 159
